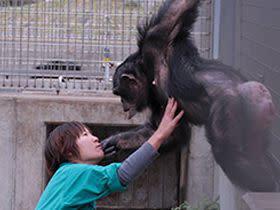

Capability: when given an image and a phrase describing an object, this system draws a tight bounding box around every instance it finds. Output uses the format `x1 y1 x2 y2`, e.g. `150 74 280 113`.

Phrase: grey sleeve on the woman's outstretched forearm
118 142 159 186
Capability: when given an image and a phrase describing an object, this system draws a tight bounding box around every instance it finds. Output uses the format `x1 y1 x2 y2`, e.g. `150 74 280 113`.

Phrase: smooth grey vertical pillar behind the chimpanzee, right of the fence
218 0 248 210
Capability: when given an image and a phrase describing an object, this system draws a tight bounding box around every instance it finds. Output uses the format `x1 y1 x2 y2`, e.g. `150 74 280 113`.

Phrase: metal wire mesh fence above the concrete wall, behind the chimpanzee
0 0 212 90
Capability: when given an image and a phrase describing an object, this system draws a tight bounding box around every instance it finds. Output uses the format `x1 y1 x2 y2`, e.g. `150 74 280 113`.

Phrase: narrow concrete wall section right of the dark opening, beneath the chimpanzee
185 127 219 209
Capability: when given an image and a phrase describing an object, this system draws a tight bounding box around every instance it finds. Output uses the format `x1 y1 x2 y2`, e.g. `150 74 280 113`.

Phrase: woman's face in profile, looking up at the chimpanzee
76 129 104 164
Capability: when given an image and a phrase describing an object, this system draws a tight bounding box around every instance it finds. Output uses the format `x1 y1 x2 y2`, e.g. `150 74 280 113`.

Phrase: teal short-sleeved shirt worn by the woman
35 163 125 210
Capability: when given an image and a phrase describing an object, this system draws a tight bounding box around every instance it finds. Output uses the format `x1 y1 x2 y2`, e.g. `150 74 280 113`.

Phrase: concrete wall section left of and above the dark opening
0 94 145 210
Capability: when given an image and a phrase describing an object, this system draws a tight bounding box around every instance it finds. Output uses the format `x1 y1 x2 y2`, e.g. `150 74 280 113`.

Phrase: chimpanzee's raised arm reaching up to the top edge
138 0 199 90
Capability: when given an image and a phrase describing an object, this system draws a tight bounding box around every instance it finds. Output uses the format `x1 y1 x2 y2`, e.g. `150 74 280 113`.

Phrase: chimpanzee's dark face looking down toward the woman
113 53 148 119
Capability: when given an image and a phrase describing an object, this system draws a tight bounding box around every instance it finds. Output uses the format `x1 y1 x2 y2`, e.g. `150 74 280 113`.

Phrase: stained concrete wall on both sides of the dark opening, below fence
0 93 217 210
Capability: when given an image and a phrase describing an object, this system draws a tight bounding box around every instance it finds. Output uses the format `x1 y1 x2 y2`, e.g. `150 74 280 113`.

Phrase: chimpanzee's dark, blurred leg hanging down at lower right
206 91 278 192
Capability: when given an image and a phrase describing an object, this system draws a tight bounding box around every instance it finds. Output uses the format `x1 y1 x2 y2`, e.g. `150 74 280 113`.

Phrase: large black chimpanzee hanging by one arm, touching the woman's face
103 0 279 191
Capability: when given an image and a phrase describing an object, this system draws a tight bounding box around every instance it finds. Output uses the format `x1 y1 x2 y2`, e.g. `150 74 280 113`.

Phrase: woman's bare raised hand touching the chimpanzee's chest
148 98 184 149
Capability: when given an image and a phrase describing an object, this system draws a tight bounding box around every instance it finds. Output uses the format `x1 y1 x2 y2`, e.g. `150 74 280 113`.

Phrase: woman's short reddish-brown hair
45 122 88 176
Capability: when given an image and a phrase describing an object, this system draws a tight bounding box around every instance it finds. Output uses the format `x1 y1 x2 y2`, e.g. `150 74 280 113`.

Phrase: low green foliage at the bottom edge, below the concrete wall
171 198 220 210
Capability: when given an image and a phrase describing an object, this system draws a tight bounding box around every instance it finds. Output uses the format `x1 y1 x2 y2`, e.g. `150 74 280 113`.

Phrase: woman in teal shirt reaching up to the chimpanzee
36 98 183 210
